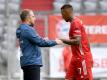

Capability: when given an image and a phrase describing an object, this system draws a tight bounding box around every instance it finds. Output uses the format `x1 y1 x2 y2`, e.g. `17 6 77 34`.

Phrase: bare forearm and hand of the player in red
60 36 81 45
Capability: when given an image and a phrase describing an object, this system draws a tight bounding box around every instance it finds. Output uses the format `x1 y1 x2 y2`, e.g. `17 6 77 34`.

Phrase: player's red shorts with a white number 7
66 58 93 80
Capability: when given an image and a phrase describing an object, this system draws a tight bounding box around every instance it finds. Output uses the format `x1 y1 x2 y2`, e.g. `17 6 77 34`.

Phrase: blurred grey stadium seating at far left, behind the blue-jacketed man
0 0 20 80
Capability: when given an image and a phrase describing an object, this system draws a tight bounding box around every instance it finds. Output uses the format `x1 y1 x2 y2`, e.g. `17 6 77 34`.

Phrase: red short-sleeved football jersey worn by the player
69 17 93 67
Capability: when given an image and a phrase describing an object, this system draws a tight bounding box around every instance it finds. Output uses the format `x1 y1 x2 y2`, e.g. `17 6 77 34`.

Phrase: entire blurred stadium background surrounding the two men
0 0 107 80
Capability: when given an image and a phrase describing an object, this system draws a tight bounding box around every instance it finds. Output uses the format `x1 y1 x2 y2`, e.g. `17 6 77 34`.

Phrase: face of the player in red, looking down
61 8 73 22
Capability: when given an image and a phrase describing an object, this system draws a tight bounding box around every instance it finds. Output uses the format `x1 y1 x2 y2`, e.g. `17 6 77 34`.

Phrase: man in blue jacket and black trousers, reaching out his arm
16 9 62 80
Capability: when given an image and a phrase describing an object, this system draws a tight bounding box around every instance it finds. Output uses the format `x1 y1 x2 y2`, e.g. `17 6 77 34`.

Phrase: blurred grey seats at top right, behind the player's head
53 0 107 13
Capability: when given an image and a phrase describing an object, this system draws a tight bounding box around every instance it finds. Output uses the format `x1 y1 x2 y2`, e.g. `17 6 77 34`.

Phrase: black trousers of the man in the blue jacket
22 65 40 80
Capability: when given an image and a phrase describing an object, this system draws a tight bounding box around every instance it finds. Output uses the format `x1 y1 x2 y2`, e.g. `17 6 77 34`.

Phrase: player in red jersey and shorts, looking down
61 4 93 80
